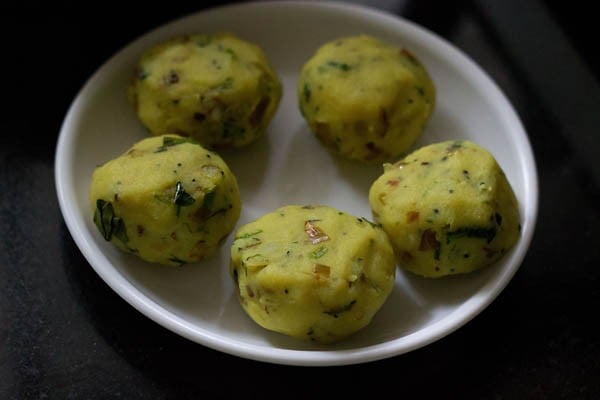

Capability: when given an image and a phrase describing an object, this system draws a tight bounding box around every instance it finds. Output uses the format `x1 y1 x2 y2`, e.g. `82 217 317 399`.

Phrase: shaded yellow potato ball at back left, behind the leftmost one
129 33 281 147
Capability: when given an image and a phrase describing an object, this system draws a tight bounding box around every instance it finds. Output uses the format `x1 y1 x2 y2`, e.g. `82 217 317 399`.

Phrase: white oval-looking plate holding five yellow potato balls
55 2 538 365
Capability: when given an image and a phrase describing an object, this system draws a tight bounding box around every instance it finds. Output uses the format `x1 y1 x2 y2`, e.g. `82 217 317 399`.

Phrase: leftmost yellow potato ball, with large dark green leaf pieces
90 135 241 265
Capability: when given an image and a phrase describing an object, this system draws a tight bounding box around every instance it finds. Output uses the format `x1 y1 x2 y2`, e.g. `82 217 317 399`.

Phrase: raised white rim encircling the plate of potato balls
54 0 539 366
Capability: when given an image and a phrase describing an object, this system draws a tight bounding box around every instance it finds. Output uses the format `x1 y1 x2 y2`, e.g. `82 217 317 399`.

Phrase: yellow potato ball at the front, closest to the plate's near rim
230 206 395 343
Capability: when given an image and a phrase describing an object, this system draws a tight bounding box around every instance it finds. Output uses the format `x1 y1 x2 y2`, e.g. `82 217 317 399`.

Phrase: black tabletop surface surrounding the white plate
0 1 600 399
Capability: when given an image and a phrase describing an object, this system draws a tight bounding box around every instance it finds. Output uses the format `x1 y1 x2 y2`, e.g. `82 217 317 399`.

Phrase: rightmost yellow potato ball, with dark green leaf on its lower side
369 141 521 278
